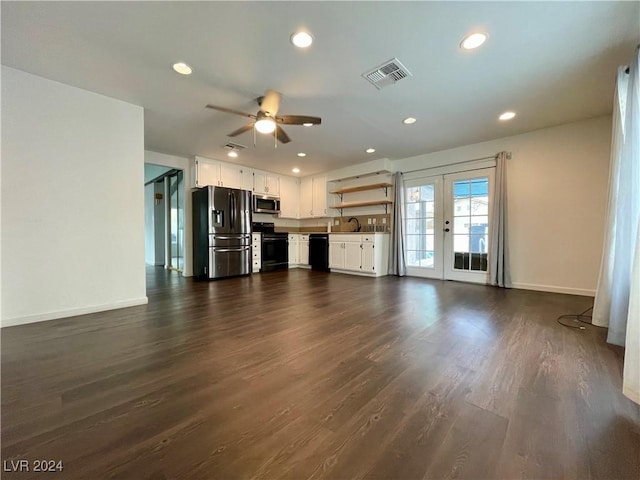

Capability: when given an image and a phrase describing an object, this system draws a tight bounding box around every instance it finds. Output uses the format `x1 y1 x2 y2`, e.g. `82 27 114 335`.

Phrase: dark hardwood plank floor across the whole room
2 268 640 480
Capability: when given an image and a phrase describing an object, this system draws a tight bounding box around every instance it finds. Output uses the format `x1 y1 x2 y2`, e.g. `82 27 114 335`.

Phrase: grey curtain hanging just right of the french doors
489 152 511 288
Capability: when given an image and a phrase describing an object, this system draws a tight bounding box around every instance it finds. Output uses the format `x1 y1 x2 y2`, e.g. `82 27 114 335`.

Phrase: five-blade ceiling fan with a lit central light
207 90 322 146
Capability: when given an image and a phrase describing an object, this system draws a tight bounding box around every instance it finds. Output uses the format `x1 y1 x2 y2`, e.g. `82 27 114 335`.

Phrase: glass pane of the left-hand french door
405 184 435 268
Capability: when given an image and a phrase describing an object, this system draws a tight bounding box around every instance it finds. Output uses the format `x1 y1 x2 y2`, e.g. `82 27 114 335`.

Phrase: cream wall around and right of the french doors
394 116 611 295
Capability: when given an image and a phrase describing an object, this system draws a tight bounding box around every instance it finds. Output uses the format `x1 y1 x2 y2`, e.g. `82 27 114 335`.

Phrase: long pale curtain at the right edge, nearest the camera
593 49 640 403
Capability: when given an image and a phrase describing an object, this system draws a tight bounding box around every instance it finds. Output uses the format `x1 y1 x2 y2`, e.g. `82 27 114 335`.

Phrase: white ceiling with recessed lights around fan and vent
1 1 640 176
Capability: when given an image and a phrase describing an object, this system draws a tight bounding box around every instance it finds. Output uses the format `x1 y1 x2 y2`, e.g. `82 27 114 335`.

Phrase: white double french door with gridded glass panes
404 168 494 283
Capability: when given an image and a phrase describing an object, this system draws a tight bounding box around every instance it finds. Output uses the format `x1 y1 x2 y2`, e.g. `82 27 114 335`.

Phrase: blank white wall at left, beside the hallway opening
1 67 147 326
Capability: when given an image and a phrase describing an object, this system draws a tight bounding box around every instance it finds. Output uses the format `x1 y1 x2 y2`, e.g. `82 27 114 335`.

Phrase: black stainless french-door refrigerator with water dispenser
192 186 252 278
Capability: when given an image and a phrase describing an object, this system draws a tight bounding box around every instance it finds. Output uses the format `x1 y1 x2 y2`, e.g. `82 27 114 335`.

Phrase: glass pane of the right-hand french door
452 177 489 271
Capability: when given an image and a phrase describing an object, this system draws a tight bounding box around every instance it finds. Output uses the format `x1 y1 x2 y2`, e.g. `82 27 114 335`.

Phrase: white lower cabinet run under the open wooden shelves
329 234 389 277
